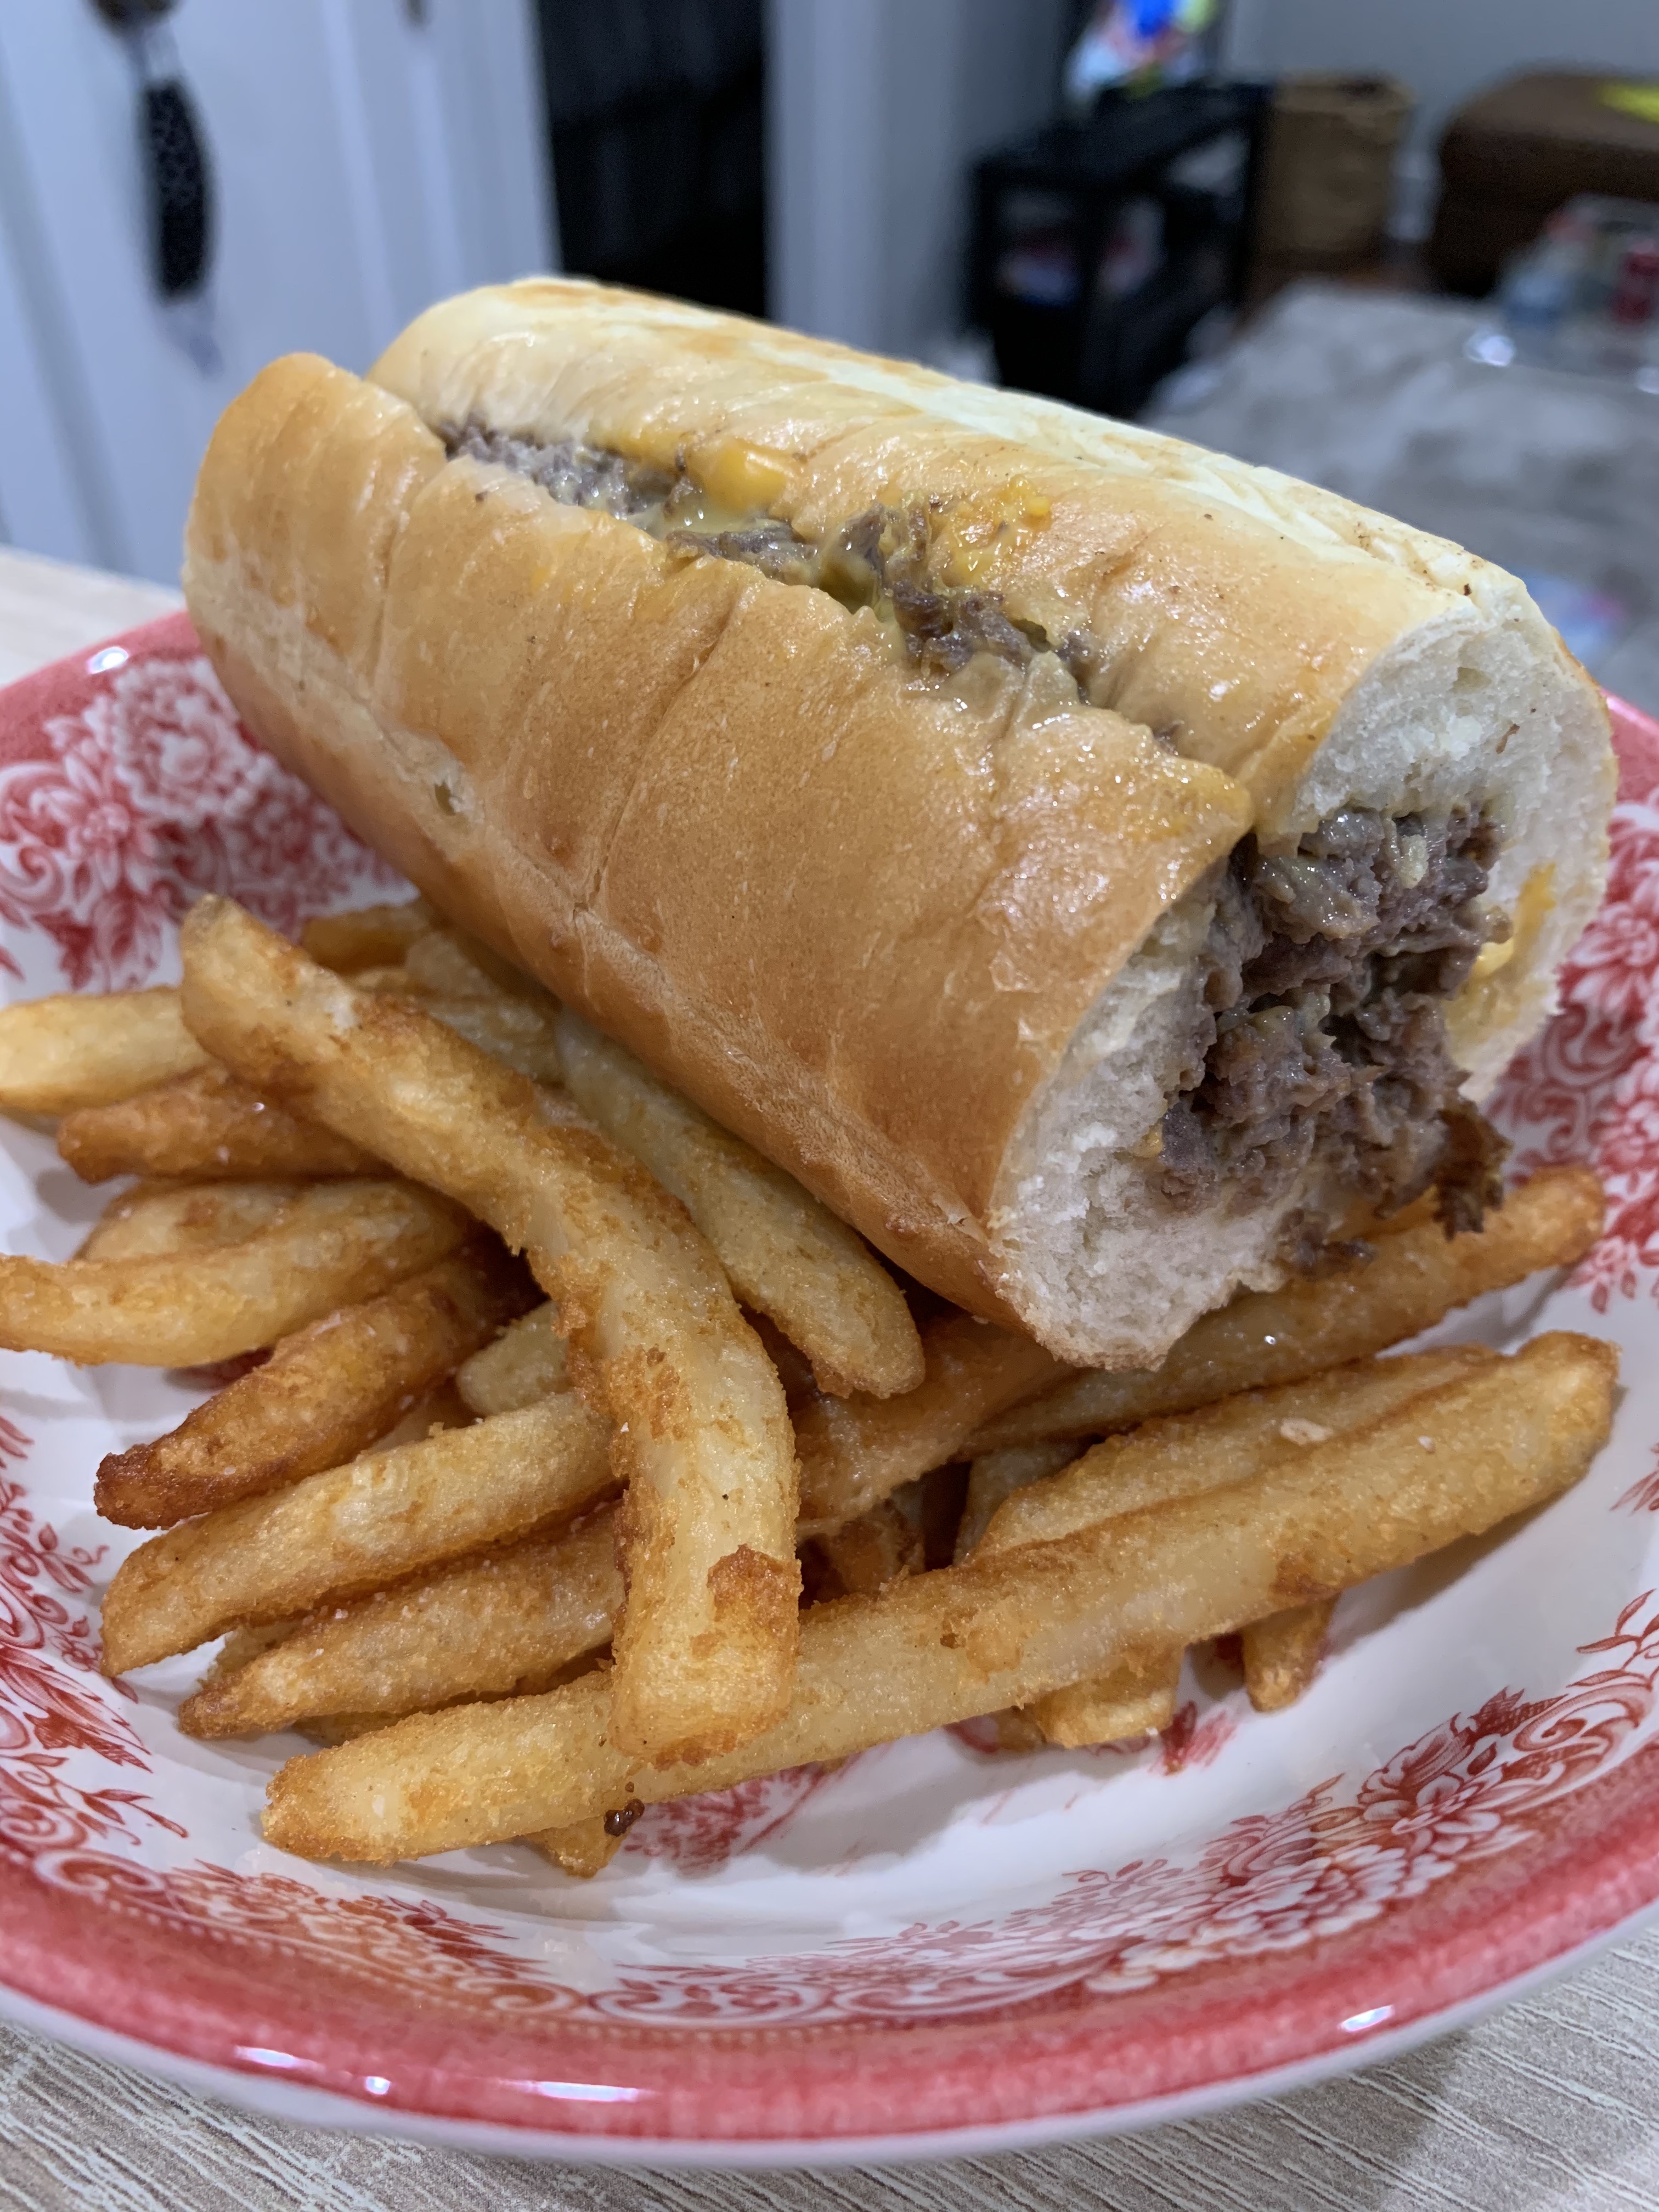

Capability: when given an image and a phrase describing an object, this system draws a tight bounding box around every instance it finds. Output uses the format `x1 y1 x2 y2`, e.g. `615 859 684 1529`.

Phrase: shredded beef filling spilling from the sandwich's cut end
1155 808 1504 1243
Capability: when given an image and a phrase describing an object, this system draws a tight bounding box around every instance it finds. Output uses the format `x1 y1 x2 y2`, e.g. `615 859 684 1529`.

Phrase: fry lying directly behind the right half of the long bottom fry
975 1345 1498 1558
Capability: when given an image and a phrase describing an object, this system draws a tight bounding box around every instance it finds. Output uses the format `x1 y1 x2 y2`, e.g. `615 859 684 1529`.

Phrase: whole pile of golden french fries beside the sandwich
0 898 1617 1874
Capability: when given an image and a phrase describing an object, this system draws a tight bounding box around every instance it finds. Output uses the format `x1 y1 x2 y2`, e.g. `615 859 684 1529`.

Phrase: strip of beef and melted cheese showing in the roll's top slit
444 422 1106 697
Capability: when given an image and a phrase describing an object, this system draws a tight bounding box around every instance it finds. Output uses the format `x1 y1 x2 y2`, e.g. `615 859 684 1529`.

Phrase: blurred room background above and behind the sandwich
0 0 1659 710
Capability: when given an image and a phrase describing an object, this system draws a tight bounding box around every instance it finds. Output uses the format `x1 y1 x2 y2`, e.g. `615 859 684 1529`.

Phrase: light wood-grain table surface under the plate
0 549 1659 2212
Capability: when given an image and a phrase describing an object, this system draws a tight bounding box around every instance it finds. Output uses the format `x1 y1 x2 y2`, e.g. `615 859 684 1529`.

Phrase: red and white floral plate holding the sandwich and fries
0 617 1659 2163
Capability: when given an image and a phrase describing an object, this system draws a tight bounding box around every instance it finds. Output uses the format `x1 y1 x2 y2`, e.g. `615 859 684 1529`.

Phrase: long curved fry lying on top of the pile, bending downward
182 898 801 1760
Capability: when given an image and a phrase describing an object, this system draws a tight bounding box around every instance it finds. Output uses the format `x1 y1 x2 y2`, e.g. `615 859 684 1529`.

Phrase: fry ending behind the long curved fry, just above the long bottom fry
179 1513 622 1736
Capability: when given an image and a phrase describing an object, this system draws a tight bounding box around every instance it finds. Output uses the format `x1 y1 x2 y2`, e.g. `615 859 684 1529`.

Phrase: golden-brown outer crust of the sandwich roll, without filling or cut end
186 281 1628 1334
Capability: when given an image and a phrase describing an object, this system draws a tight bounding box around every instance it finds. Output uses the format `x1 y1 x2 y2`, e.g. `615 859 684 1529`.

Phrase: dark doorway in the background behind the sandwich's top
540 0 765 314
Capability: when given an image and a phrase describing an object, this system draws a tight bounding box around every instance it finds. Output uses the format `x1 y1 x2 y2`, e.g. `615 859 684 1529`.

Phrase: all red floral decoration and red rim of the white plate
0 619 1659 2143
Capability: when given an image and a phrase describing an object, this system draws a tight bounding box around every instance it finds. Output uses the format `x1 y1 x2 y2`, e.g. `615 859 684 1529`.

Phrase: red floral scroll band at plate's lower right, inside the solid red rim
591 1593 1659 2026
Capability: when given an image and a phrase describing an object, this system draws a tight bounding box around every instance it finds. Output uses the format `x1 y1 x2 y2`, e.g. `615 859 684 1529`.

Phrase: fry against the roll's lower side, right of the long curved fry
557 1009 922 1398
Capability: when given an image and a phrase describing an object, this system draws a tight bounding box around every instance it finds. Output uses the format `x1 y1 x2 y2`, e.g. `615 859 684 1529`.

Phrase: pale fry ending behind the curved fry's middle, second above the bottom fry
104 1393 613 1672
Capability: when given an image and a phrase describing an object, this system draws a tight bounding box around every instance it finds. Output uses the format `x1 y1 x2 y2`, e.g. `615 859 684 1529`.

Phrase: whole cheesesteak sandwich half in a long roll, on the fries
184 281 1612 1365
